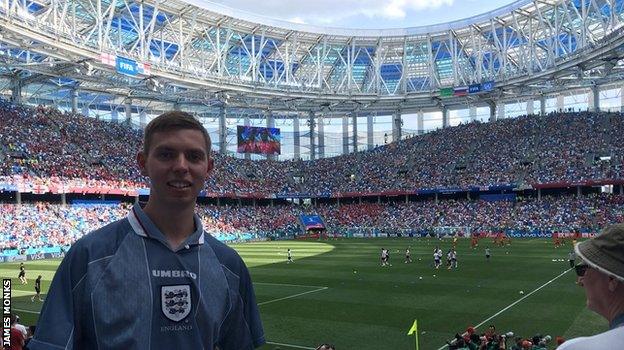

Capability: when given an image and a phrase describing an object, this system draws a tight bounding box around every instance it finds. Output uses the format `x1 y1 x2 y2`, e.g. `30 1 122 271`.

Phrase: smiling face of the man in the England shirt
137 129 213 209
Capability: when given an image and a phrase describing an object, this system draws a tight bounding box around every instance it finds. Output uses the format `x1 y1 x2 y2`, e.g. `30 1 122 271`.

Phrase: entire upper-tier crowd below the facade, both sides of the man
0 101 624 195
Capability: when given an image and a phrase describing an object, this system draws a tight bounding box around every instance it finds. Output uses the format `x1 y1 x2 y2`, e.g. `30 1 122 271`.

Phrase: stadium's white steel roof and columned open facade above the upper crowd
0 0 624 159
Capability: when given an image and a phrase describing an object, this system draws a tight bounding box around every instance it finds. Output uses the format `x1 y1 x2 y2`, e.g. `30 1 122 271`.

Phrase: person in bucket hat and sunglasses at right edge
557 224 624 350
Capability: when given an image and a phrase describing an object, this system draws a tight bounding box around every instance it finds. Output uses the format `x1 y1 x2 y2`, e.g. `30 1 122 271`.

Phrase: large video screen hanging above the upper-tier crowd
236 125 282 154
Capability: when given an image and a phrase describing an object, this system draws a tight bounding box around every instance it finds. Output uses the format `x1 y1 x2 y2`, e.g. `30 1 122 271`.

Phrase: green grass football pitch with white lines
0 238 607 350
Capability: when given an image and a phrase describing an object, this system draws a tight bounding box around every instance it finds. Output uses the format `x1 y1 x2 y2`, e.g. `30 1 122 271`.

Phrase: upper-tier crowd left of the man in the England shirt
0 100 144 188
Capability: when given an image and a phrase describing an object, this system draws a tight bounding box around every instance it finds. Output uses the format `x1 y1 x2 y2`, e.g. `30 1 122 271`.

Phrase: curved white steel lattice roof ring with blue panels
0 0 624 112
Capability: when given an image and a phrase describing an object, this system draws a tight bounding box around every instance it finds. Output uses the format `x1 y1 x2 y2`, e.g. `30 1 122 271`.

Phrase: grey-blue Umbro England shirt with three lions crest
28 204 265 350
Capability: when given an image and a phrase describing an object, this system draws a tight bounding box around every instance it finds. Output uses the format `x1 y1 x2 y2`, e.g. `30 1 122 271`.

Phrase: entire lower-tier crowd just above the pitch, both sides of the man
0 194 624 249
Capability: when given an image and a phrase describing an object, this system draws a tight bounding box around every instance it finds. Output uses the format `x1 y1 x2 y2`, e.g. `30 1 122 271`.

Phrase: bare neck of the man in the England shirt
143 201 195 250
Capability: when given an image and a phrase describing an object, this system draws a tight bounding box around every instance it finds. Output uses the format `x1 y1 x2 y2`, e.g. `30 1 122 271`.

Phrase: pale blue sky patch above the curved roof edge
210 0 514 29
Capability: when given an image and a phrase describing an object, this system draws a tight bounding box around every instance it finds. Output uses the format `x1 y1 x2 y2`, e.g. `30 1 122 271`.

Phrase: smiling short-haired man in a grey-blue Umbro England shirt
29 111 265 350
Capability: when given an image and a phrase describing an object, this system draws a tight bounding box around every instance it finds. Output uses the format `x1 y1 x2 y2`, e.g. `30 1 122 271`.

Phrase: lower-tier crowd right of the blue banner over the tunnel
317 194 624 234
